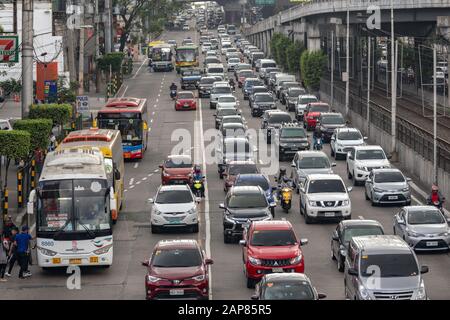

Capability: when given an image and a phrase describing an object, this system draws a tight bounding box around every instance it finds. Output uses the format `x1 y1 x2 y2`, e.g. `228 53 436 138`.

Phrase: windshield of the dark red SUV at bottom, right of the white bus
151 249 202 268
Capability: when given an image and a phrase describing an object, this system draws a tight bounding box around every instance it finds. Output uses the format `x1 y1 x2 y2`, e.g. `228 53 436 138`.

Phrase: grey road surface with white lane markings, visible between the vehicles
0 27 450 300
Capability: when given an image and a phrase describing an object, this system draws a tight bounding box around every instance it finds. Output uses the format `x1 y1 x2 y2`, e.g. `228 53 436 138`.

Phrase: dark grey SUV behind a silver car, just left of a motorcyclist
274 123 310 161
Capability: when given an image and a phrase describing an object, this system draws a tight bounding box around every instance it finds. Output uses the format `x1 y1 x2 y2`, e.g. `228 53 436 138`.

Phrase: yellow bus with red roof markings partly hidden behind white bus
57 128 125 224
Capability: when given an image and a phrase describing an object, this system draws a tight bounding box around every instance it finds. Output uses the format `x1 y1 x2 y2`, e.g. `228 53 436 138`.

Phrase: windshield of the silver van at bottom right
360 253 419 278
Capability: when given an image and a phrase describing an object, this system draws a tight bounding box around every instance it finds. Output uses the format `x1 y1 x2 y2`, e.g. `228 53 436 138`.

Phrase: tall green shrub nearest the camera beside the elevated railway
300 50 327 90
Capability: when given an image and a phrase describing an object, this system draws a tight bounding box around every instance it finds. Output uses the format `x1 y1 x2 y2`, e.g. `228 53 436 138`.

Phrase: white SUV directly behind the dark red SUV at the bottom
149 184 200 233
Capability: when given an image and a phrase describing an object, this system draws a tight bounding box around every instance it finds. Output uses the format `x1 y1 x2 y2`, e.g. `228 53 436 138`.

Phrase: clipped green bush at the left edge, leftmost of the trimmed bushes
0 130 31 159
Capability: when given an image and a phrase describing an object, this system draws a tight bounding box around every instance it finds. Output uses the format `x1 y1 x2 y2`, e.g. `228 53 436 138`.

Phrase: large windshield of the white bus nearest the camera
37 179 111 232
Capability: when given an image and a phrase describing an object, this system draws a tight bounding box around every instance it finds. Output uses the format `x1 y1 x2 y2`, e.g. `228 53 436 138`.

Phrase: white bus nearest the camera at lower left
27 148 117 269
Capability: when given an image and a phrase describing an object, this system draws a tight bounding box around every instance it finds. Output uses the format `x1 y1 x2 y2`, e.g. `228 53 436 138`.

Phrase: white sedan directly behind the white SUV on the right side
330 128 367 160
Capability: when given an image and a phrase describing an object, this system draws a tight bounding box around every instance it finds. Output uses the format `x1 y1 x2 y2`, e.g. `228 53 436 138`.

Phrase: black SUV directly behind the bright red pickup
219 186 272 243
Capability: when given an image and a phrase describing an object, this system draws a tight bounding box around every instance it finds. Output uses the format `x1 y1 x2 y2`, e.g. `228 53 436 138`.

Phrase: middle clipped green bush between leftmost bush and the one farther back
14 119 53 150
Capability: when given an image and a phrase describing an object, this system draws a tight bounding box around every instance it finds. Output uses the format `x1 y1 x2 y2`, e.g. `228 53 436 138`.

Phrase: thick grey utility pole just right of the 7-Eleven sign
22 0 33 119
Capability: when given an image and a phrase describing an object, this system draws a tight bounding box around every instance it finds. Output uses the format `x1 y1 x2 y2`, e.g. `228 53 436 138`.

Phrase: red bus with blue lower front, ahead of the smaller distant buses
97 98 148 159
